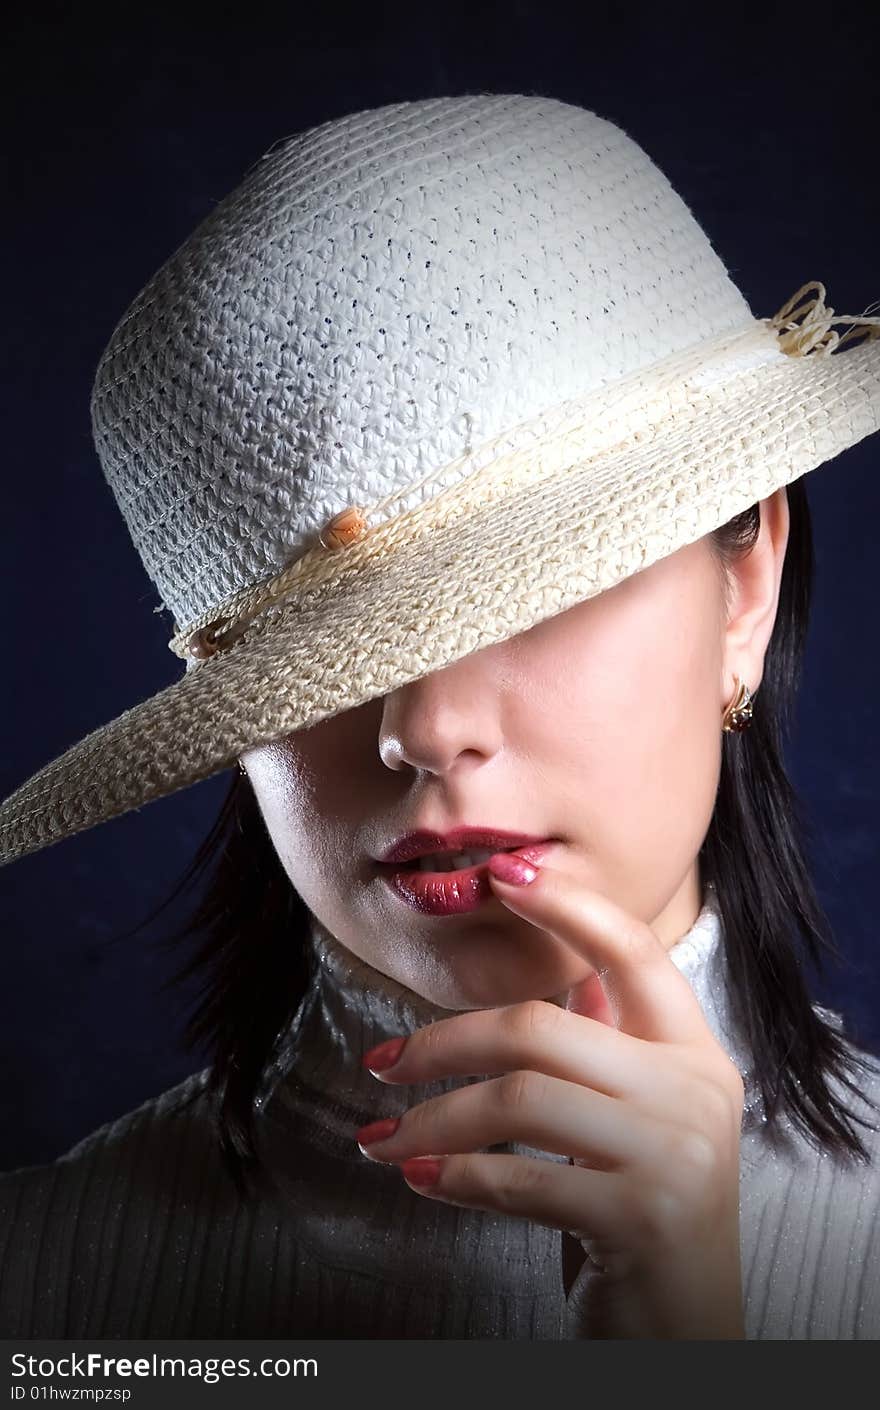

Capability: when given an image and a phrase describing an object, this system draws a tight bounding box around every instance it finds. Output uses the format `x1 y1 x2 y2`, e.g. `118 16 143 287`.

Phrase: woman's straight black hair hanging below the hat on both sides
108 479 869 1197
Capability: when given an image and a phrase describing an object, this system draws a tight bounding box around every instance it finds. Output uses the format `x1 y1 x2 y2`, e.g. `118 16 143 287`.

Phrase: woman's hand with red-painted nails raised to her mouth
357 843 745 1340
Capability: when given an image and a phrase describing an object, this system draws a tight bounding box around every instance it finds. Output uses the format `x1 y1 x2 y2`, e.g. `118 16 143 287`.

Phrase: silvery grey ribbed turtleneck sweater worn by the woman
0 888 880 1340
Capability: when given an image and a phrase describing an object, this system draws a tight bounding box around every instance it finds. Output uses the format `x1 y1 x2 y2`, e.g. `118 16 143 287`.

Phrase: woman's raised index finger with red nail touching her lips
488 843 715 1043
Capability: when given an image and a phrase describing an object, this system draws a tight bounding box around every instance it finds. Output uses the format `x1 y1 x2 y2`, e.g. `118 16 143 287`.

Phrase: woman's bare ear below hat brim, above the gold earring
721 485 790 706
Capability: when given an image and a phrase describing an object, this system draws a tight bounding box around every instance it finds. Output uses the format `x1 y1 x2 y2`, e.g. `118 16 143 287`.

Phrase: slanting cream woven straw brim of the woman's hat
0 338 880 864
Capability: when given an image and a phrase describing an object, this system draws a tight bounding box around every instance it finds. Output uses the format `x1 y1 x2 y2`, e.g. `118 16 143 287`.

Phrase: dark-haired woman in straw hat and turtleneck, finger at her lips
0 94 880 1340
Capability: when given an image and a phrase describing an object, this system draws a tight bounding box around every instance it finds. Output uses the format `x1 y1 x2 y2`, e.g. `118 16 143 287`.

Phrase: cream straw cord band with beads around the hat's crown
169 281 880 668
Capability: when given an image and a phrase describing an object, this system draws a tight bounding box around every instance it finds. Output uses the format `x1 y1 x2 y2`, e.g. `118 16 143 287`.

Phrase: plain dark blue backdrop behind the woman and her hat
0 0 880 1169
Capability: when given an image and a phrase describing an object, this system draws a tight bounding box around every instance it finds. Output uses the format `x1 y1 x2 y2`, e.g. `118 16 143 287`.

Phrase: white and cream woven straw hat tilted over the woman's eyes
0 93 880 863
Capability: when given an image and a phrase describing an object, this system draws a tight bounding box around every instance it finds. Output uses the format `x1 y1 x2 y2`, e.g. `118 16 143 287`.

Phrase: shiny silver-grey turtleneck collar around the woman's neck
257 883 760 1121
